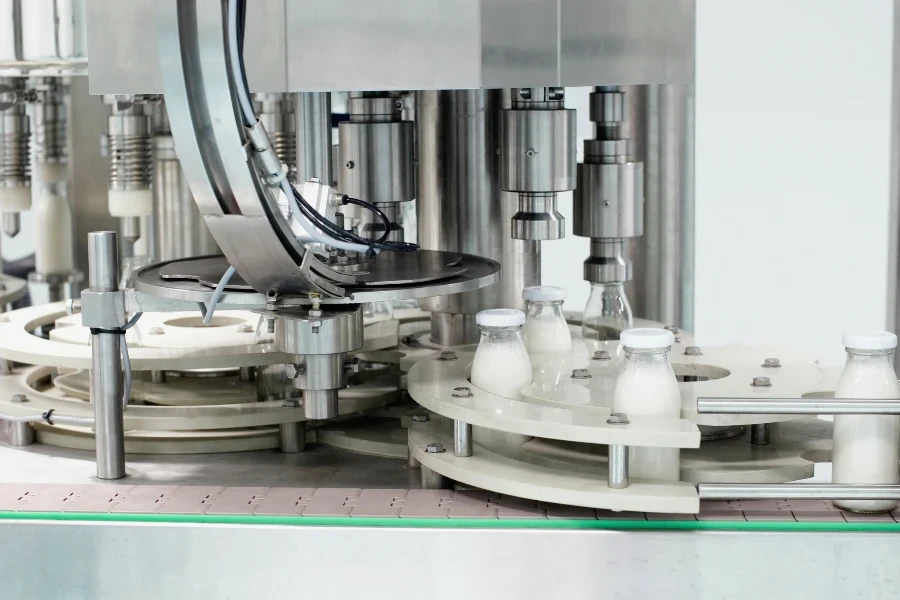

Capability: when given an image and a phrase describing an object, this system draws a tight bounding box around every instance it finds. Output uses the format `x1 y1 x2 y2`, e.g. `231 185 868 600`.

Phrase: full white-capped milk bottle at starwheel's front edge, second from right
613 328 681 481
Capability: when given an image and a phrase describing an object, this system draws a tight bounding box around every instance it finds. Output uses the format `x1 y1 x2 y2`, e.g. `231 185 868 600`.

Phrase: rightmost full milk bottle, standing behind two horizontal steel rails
832 331 900 512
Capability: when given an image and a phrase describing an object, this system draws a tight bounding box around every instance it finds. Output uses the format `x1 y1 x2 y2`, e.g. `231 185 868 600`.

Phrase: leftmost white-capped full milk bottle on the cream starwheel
471 308 531 400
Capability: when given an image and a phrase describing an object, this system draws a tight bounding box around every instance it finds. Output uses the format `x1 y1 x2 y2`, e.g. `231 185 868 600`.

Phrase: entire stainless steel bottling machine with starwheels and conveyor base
0 0 900 598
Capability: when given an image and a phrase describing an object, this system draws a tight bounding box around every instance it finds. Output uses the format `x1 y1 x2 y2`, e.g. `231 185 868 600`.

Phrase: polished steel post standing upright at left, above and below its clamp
88 231 125 479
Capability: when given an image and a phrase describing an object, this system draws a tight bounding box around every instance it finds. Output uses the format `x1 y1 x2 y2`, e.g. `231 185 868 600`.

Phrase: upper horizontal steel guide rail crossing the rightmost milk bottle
697 397 900 415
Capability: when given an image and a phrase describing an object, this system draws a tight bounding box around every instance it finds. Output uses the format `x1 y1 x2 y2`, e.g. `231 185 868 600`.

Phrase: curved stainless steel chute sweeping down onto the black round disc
154 0 338 295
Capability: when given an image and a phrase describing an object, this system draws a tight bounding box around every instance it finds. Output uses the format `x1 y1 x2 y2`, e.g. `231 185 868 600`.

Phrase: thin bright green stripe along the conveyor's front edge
0 511 900 532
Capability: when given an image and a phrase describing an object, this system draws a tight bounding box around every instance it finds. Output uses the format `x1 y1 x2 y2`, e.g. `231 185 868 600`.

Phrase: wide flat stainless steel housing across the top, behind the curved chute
87 0 695 94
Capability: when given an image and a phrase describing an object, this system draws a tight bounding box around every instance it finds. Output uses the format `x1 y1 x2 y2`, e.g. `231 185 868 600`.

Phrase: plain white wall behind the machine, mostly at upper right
543 0 893 366
